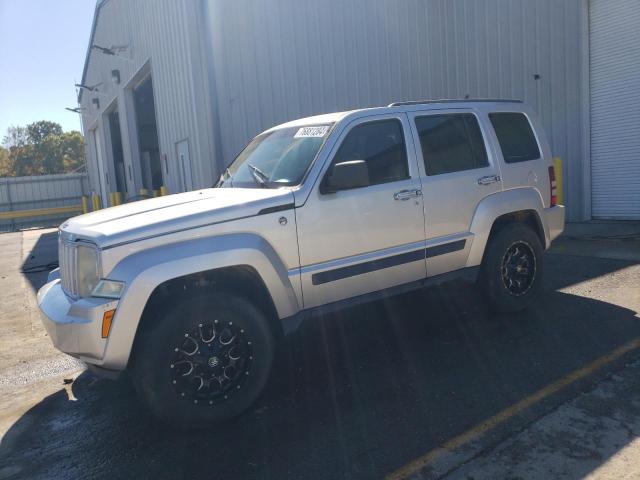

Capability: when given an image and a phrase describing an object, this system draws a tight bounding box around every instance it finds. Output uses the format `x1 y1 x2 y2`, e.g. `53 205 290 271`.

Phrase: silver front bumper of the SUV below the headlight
38 279 118 366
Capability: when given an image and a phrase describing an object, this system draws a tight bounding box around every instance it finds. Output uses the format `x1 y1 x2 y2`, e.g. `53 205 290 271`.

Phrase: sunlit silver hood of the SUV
60 188 294 248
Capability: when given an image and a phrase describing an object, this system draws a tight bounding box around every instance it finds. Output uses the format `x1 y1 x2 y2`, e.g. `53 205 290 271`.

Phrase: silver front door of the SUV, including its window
296 113 426 308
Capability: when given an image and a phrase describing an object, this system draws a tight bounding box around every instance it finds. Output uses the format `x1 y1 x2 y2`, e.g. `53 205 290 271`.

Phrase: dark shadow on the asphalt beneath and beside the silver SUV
5 251 640 479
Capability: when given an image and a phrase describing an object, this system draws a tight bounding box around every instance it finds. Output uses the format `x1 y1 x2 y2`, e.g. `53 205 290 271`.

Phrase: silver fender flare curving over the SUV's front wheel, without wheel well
103 234 300 370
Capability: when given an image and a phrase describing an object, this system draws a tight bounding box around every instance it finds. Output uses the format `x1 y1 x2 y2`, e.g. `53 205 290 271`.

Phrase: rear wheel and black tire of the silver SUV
478 223 544 313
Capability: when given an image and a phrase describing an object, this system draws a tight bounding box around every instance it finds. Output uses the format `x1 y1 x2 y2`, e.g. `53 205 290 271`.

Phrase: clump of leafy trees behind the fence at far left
0 120 85 176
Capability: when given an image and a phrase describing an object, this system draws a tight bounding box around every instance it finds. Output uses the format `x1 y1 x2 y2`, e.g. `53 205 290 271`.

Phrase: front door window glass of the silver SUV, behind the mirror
332 120 409 185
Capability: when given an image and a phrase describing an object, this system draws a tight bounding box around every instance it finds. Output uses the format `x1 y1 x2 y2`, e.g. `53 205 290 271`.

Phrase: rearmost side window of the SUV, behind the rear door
489 112 540 163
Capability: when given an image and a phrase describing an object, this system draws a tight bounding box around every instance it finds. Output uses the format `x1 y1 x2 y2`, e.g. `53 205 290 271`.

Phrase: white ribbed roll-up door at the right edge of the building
590 0 640 219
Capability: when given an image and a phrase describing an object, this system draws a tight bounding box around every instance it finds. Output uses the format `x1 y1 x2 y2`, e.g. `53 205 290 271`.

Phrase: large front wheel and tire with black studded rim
131 293 275 430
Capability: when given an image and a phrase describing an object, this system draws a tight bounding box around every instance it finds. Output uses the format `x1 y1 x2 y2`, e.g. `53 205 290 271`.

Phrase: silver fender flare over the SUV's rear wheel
467 187 550 267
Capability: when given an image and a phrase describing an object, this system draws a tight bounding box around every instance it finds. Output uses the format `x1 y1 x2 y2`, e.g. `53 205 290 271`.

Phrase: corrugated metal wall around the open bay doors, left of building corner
82 0 217 197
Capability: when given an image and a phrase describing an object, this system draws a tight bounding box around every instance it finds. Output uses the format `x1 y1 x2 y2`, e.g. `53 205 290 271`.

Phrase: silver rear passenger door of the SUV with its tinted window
409 109 502 276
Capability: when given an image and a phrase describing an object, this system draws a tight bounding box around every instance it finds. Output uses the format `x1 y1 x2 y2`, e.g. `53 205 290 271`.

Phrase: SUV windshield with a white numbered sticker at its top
217 124 331 188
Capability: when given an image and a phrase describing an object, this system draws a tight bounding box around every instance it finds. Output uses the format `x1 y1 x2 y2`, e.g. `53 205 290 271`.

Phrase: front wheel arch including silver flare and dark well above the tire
104 234 300 370
